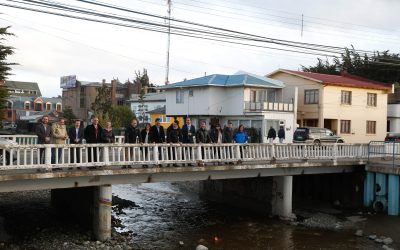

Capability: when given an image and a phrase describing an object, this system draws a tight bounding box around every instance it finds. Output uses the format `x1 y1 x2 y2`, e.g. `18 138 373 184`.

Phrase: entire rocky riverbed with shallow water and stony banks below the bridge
0 187 400 250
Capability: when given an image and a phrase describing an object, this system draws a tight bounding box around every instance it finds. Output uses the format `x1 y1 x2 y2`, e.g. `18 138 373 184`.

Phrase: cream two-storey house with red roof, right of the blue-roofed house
267 69 392 143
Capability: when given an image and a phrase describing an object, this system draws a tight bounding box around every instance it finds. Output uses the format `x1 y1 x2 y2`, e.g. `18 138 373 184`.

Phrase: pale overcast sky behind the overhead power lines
0 0 400 97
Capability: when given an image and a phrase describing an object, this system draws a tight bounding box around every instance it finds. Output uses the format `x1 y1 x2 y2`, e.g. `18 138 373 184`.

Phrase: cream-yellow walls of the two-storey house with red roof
271 72 387 143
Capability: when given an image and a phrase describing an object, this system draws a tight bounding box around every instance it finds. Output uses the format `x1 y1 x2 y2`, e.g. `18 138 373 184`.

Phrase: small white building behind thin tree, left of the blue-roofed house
127 92 166 123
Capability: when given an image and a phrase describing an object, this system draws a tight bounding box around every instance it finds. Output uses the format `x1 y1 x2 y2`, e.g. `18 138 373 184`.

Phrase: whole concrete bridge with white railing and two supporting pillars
0 136 391 240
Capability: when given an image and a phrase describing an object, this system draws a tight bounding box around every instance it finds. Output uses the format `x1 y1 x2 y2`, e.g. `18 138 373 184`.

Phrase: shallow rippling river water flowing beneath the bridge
113 183 393 249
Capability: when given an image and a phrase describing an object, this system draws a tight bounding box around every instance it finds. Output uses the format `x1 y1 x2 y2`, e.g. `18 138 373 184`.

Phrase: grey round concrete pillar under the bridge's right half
271 176 293 219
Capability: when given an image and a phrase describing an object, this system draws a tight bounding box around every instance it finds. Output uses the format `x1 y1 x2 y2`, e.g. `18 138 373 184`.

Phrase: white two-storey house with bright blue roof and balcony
160 72 297 142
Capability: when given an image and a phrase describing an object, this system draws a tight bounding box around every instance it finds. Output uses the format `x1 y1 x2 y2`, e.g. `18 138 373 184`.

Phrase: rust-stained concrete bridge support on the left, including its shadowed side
51 185 112 241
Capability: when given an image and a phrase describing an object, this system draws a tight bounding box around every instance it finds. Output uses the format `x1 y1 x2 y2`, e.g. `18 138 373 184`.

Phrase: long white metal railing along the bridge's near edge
0 143 376 170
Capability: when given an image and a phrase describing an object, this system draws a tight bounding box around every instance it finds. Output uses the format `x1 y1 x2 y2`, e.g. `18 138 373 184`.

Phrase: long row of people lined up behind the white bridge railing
36 115 256 163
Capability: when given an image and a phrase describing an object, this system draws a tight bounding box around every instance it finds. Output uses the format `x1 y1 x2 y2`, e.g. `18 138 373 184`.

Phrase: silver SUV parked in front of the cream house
293 127 344 144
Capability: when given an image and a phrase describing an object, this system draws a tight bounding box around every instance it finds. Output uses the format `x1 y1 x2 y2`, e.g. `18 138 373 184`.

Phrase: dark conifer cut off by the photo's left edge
0 26 17 114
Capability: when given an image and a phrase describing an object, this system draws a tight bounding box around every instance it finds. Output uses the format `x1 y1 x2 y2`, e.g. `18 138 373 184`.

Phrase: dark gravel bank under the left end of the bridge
0 190 139 250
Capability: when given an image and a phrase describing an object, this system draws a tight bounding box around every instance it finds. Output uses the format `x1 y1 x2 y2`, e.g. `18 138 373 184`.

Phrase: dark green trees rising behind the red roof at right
301 47 400 83
